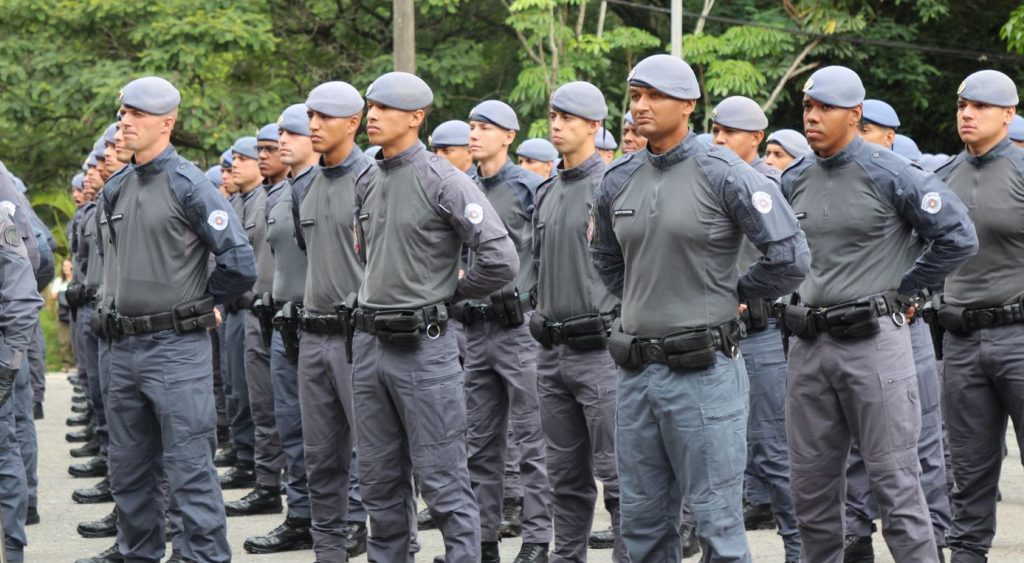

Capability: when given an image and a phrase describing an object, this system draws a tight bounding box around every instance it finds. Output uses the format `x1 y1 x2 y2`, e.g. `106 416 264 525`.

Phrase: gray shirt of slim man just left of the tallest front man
534 153 618 322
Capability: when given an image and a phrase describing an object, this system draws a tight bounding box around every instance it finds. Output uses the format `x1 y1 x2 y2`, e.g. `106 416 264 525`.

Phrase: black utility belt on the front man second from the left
351 303 449 346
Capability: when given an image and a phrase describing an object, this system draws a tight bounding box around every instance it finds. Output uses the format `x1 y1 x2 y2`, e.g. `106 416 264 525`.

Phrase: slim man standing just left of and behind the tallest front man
530 82 626 563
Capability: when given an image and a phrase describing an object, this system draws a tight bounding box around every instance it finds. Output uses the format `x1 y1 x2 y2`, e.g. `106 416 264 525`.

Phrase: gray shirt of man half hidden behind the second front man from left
299 146 370 314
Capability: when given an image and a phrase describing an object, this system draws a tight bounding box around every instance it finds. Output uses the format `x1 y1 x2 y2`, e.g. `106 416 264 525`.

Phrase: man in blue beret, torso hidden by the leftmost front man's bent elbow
219 136 262 491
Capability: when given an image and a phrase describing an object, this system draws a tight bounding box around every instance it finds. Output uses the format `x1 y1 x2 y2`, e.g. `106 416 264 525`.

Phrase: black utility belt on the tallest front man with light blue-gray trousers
608 320 739 370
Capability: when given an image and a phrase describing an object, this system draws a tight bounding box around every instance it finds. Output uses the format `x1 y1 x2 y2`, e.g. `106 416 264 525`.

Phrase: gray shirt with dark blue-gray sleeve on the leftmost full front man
103 146 256 316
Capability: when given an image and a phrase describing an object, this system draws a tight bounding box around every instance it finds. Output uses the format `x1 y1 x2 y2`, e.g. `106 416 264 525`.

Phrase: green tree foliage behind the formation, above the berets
0 0 1024 253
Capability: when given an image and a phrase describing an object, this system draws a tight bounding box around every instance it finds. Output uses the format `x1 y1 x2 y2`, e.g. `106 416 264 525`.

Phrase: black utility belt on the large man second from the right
779 292 906 340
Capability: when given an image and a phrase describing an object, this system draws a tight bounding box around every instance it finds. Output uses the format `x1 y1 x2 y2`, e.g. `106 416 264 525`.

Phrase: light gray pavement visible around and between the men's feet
26 374 1024 563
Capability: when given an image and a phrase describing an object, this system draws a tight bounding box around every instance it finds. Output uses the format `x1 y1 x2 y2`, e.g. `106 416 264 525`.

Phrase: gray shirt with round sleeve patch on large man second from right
782 137 977 307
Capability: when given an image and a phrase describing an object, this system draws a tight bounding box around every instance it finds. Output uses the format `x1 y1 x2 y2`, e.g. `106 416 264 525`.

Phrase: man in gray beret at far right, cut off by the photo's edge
930 70 1024 563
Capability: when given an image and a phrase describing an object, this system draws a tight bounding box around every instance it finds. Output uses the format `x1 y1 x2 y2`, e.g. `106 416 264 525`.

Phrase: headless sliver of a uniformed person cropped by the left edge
0 206 43 563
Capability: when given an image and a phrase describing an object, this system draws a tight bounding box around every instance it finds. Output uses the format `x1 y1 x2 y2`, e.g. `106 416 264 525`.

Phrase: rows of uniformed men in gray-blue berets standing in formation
0 51 1024 563
